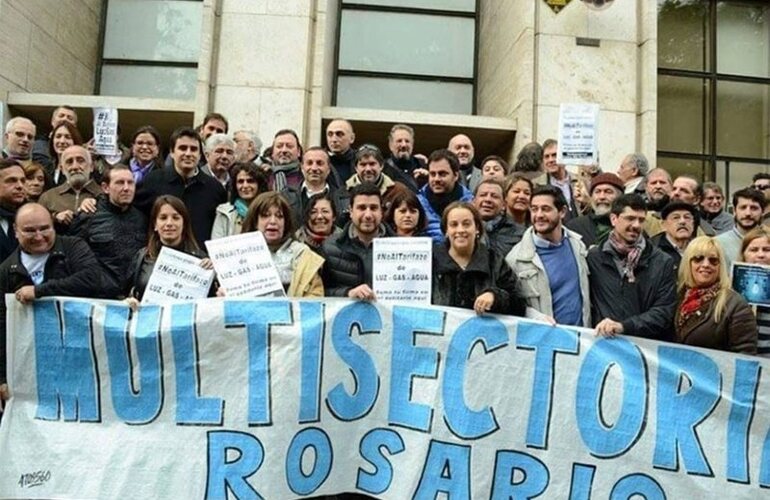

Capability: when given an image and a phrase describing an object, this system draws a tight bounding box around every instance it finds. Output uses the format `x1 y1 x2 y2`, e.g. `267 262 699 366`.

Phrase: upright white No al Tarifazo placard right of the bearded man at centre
372 238 433 305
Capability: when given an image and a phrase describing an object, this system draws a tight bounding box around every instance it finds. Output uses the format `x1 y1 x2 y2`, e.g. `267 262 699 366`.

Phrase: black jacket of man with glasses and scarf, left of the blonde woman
587 241 676 340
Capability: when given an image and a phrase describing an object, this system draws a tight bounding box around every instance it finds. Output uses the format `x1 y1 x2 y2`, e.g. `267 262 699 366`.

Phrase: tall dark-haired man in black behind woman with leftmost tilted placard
135 127 227 248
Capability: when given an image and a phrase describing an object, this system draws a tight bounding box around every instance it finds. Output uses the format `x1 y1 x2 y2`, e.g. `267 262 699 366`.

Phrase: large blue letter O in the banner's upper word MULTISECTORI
575 337 647 458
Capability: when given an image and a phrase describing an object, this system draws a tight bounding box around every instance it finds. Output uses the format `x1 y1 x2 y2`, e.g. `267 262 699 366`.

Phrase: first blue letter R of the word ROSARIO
206 431 265 500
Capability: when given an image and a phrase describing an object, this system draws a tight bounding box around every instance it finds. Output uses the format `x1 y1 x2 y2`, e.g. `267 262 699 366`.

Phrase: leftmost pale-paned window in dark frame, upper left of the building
97 0 203 100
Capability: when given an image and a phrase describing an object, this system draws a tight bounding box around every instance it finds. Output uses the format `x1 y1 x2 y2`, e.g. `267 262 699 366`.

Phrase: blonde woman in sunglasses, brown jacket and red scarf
674 236 757 354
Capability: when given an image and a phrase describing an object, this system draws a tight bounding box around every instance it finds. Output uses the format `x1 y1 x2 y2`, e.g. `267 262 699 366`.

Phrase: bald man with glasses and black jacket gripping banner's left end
0 203 102 406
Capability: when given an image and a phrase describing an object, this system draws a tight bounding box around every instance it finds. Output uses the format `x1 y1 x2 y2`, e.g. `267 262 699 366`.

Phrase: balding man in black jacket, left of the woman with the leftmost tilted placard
70 164 147 298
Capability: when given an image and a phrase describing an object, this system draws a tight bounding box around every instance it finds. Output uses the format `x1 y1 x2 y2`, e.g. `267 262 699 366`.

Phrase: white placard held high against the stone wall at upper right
556 104 599 165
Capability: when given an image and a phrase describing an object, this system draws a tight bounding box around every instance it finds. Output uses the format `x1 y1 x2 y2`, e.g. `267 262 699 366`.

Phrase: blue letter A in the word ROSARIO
412 439 471 500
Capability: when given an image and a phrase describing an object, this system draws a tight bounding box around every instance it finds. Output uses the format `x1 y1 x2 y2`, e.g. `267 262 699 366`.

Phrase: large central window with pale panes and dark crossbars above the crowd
334 0 477 114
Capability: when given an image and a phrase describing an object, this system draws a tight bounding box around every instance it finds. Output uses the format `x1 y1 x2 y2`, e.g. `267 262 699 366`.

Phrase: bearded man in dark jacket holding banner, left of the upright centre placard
321 183 387 300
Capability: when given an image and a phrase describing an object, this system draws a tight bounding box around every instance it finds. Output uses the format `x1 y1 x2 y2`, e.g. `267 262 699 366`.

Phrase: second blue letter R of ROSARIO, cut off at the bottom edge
489 450 551 500
